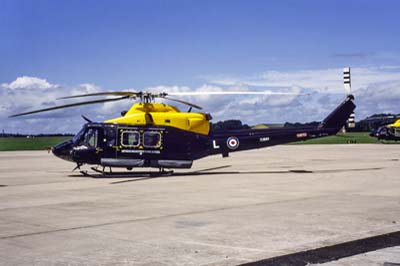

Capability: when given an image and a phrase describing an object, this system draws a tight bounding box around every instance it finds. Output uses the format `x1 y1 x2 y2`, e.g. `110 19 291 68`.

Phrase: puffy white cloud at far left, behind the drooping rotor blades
0 76 106 133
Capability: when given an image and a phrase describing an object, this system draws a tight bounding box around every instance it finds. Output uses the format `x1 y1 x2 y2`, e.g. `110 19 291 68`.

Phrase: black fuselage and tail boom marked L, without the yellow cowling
53 96 355 168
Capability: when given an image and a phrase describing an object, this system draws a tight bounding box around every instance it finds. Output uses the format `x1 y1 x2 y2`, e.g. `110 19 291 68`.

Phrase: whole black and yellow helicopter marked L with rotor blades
11 69 356 176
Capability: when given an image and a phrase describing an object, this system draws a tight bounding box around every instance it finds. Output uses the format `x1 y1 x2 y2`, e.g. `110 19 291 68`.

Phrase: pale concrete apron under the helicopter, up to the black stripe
0 145 400 265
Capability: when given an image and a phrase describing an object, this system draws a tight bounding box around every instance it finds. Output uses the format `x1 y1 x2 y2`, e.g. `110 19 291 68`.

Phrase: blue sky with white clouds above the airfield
0 0 400 134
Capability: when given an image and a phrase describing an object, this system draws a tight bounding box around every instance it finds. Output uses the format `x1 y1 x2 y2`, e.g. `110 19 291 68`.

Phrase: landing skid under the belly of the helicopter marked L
80 167 174 178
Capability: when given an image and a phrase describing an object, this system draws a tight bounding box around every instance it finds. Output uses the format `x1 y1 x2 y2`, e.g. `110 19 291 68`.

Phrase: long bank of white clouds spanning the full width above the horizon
0 66 400 133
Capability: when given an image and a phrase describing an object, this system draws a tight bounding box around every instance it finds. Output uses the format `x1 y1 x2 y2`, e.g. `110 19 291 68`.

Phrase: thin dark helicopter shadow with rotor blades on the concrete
69 165 383 184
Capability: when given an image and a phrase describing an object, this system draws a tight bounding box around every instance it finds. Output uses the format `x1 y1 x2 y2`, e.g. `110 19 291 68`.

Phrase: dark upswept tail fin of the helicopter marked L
320 94 356 132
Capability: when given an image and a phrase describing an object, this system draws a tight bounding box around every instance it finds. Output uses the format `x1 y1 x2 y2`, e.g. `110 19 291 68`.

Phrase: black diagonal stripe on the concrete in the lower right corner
241 231 400 266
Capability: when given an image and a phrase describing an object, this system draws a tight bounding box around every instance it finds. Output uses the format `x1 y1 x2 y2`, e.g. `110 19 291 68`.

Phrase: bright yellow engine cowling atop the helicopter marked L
104 103 210 135
